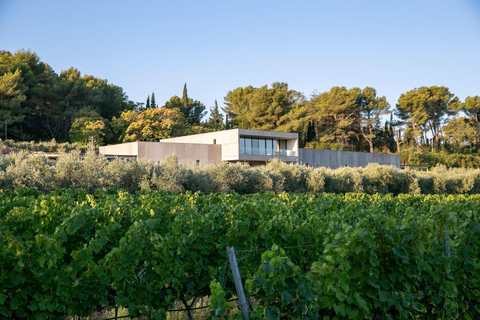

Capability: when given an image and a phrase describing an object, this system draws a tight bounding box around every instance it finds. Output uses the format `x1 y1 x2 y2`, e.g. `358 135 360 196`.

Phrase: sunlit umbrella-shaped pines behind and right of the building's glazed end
224 83 480 156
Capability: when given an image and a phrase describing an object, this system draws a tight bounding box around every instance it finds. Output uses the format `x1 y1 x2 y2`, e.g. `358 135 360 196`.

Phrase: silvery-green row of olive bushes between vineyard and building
0 151 480 195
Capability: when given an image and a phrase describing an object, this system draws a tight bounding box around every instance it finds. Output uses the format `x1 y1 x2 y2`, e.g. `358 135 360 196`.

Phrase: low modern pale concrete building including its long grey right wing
100 129 400 168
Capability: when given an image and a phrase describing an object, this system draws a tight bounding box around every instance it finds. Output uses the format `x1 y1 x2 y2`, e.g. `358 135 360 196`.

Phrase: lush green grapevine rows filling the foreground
0 189 480 319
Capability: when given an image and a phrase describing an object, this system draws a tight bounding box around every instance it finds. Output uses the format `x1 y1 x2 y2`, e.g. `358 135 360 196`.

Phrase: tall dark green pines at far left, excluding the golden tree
0 50 135 142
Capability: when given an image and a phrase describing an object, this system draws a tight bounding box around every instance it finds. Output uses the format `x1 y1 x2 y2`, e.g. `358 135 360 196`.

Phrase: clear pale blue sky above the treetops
0 0 480 114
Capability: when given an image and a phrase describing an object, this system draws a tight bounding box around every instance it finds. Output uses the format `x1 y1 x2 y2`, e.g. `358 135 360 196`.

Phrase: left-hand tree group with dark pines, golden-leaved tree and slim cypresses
0 50 212 145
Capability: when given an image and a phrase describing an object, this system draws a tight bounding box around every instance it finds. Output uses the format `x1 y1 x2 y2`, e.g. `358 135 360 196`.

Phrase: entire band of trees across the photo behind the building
0 50 480 165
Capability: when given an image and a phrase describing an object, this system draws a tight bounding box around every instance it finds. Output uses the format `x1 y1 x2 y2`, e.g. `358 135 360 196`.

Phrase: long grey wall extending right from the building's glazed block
298 149 400 169
